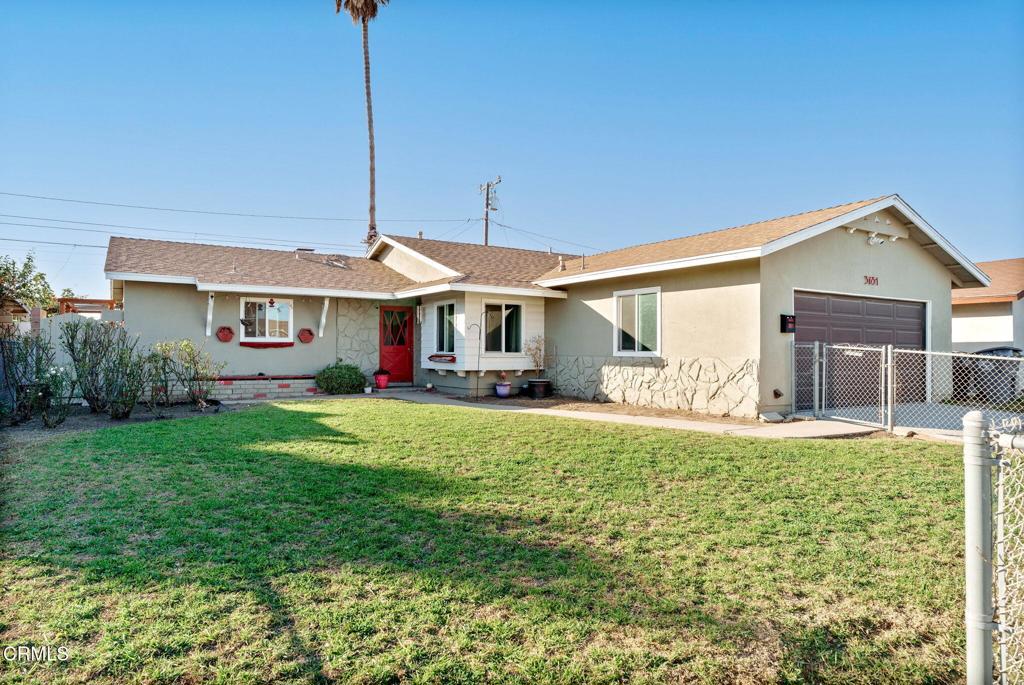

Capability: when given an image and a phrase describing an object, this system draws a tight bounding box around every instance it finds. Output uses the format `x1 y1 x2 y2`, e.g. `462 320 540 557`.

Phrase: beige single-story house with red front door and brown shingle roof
105 196 988 416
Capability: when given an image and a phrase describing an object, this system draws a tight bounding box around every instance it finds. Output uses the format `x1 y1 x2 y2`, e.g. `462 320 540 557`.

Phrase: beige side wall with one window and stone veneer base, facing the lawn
545 260 760 416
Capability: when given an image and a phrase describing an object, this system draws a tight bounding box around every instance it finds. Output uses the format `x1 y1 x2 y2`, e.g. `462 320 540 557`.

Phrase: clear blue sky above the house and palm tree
0 0 1024 296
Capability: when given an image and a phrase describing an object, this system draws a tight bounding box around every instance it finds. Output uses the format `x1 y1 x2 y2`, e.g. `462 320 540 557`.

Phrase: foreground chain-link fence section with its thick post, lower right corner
963 412 1024 685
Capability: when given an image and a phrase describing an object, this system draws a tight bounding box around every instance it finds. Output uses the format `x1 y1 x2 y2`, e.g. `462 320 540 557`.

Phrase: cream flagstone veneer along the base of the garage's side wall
547 355 758 418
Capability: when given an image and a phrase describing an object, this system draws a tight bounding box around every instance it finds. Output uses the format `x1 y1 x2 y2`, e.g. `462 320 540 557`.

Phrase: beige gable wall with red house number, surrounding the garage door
760 220 952 411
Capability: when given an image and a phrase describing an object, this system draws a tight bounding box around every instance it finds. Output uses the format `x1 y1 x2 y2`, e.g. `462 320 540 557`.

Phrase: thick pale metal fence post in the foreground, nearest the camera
964 412 993 685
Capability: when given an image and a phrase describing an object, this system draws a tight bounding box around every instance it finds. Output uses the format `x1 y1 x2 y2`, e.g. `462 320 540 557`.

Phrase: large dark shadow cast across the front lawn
5 405 737 678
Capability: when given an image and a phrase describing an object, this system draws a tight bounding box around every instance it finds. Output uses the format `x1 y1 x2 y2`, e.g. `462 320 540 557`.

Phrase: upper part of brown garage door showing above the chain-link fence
794 291 925 349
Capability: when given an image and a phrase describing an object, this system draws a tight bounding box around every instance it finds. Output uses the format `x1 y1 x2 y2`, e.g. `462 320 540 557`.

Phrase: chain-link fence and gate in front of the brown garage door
792 343 1024 431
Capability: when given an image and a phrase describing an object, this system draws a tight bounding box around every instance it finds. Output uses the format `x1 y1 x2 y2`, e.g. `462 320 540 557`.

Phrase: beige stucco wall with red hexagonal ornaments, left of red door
124 282 413 375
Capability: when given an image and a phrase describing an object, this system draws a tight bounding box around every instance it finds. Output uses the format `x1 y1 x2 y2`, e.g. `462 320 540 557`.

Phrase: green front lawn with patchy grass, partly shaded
0 399 964 684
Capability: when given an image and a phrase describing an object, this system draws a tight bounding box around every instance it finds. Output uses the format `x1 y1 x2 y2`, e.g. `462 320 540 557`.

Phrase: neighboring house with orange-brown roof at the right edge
952 257 1024 352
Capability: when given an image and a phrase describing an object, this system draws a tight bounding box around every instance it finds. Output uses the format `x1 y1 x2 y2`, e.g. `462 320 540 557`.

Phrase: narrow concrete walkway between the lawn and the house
372 389 878 439
